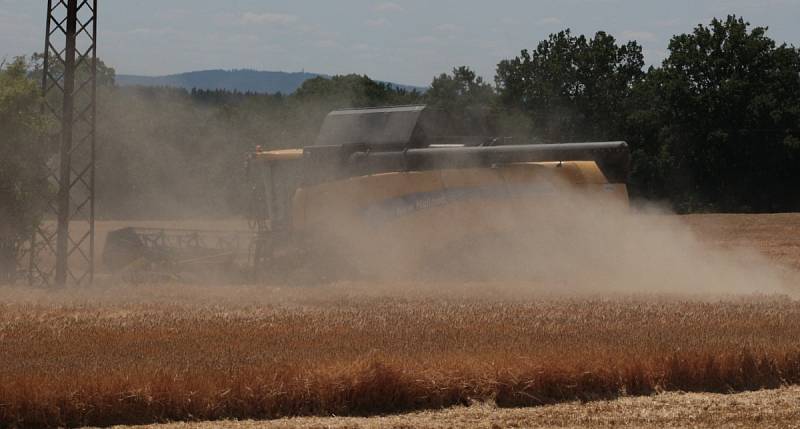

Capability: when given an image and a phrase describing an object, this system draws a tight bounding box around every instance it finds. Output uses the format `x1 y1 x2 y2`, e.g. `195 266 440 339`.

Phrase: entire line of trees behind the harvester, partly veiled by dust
0 16 800 241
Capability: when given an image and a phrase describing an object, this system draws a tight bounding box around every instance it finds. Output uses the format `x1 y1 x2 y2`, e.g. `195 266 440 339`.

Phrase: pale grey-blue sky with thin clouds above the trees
0 0 800 86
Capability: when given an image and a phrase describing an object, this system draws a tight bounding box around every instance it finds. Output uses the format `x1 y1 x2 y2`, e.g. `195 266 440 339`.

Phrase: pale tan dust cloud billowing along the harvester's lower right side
322 173 792 294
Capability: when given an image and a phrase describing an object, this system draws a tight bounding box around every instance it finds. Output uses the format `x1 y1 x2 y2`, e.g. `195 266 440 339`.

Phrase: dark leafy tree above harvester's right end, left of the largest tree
495 30 645 141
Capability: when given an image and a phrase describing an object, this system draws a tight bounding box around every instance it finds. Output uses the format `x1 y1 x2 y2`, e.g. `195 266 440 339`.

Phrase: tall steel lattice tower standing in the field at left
28 0 97 287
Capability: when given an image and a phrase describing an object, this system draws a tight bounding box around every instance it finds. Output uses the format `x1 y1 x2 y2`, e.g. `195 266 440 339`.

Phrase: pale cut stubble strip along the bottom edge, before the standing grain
109 387 800 429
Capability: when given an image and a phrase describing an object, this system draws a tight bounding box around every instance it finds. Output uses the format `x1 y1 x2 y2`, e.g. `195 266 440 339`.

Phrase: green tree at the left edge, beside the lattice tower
0 57 48 239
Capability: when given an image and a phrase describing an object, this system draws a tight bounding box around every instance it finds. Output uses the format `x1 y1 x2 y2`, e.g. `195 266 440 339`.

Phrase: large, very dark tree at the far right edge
643 16 800 211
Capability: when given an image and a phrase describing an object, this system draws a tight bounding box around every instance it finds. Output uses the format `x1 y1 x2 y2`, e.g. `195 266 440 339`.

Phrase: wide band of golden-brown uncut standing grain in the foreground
0 285 800 427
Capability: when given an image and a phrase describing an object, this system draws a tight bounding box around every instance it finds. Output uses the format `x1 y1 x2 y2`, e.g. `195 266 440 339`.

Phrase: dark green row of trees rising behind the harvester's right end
438 16 800 212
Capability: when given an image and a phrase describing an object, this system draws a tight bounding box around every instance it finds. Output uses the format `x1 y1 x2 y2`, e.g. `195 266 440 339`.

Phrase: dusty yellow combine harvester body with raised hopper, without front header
248 106 629 279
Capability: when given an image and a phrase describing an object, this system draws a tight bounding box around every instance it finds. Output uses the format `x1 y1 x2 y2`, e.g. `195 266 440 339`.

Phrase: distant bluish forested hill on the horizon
116 70 426 94
